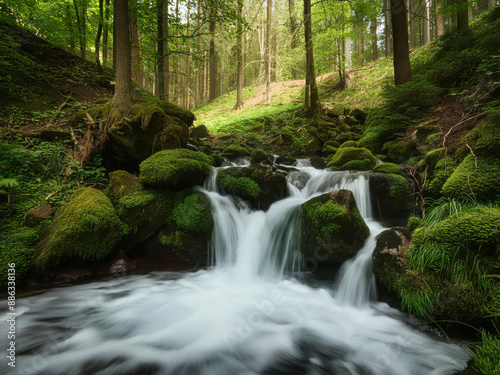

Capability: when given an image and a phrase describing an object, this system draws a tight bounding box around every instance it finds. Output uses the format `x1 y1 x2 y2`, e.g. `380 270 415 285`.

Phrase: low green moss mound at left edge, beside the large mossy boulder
0 227 40 286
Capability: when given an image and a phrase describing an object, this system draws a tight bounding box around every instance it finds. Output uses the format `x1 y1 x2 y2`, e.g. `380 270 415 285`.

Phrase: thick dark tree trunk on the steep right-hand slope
391 0 411 85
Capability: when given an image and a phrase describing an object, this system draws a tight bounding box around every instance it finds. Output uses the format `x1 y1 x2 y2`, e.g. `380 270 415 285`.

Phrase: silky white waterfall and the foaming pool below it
0 160 468 375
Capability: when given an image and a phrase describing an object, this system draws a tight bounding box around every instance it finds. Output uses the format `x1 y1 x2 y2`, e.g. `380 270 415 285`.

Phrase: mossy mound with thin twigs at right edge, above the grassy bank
441 155 500 201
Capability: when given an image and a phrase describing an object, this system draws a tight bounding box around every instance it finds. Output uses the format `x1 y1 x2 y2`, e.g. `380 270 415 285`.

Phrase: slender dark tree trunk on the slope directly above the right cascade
304 0 319 115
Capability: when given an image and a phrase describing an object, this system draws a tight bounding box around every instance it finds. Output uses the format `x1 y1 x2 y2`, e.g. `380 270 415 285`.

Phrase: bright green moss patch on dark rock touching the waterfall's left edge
172 192 214 233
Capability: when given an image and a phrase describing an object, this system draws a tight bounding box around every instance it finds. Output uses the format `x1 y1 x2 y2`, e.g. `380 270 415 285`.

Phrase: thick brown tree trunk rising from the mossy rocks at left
112 0 132 113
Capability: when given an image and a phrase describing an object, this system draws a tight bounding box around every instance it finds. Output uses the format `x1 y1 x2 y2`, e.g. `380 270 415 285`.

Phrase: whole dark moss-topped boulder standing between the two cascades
301 190 370 266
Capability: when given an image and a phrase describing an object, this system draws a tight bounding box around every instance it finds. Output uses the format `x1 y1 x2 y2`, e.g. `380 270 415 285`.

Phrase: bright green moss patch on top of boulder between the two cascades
304 201 344 238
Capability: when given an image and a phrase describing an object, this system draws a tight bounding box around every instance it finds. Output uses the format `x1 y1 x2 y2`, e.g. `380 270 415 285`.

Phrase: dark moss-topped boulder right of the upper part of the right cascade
370 173 414 226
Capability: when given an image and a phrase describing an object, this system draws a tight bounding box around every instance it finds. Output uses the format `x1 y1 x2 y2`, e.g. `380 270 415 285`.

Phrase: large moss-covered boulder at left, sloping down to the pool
34 188 123 270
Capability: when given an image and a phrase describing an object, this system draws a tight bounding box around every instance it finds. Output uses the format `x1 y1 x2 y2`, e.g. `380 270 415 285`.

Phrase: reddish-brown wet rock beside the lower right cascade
372 227 411 290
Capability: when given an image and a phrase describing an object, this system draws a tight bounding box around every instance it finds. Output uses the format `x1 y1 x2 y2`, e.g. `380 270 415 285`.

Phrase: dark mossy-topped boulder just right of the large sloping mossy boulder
116 186 173 252
